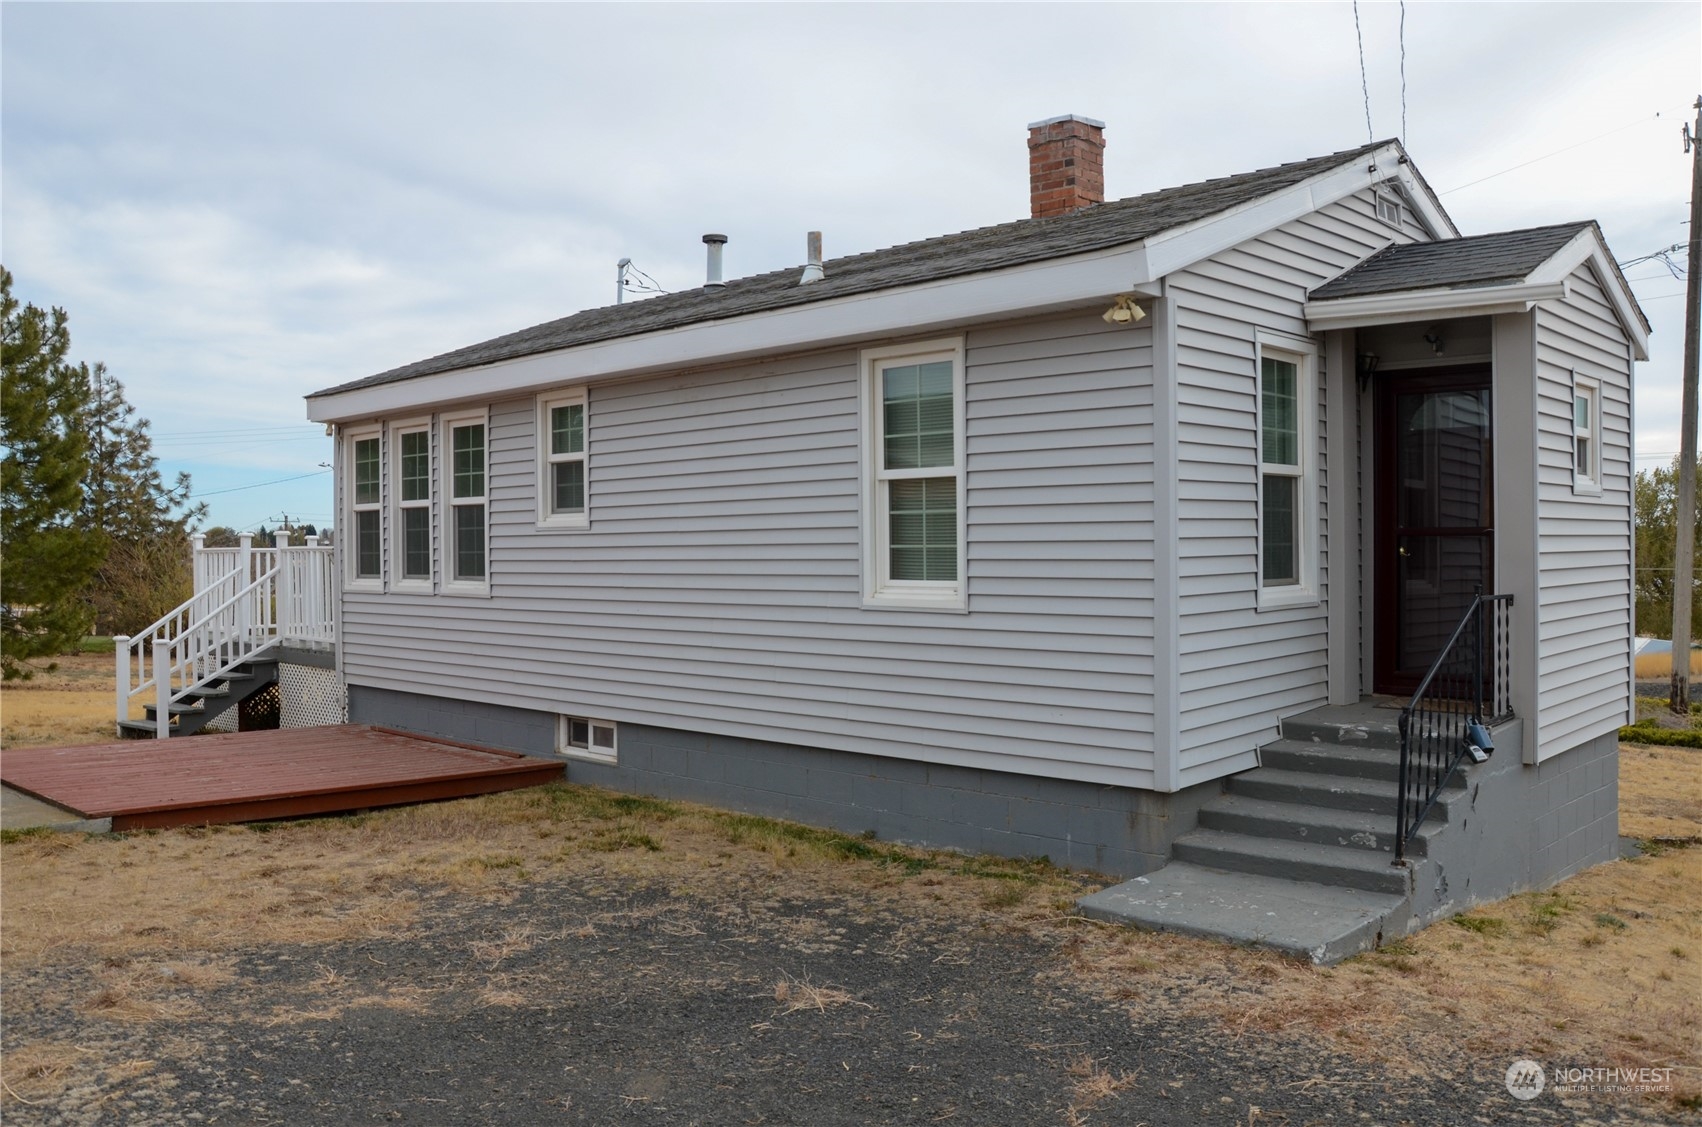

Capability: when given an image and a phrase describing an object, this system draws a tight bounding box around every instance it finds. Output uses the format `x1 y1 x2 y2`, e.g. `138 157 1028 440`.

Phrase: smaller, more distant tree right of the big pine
80 364 206 633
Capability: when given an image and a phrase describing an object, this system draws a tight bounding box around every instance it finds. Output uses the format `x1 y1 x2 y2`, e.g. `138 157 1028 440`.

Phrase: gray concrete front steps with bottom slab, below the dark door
1081 701 1471 964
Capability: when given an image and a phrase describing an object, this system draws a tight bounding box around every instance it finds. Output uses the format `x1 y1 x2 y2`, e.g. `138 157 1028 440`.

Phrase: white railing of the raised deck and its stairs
112 533 337 739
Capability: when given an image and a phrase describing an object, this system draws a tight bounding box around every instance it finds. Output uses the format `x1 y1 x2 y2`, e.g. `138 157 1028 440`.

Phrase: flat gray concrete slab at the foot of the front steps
1077 861 1406 965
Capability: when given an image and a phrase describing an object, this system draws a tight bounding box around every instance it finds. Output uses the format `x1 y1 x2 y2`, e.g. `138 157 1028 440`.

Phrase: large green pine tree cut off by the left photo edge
0 267 102 681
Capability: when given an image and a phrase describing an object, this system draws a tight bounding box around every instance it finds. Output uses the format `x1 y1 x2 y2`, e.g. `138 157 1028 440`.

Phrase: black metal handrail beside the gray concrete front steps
1394 592 1513 865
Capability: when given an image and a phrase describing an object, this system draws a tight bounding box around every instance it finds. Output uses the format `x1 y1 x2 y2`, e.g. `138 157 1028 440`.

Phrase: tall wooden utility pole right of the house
1666 97 1702 717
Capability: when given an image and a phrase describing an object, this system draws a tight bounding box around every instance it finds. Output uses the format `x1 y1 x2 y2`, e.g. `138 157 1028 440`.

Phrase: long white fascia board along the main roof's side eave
308 243 1162 422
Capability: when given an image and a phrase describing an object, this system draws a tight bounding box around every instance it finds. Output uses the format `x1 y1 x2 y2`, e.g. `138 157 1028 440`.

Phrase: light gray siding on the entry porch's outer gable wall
1537 266 1632 759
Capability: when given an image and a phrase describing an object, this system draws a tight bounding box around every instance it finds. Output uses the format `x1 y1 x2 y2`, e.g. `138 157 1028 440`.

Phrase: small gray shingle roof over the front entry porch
1311 223 1595 301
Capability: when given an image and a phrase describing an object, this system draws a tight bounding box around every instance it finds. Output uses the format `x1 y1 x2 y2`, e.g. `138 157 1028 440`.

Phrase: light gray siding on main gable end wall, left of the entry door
1168 191 1423 787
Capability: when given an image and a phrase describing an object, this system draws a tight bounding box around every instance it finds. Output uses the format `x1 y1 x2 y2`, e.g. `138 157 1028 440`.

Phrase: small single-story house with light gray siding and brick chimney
308 116 1648 957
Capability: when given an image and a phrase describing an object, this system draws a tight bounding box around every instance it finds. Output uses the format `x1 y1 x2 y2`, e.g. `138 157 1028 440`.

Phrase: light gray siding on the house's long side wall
331 310 1152 787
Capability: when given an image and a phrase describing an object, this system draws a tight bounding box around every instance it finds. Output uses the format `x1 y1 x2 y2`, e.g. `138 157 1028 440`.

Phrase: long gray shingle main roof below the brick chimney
310 141 1391 398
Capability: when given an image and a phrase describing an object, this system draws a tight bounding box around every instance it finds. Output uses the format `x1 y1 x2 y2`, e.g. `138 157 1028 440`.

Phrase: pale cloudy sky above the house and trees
0 2 1702 528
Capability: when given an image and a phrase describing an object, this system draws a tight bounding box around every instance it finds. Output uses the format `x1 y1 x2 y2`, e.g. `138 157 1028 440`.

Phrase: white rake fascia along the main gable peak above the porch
1145 145 1459 277
